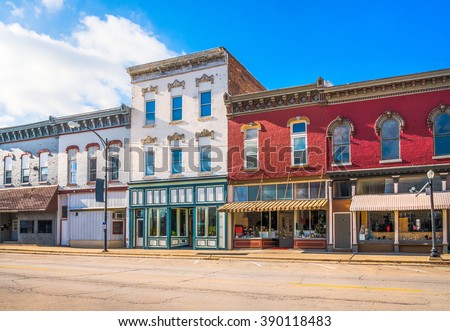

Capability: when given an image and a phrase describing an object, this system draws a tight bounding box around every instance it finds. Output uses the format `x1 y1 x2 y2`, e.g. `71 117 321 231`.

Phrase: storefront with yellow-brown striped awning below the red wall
219 182 328 249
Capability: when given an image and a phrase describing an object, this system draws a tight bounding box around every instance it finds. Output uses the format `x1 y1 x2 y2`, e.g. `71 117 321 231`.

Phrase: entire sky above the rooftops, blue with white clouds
0 0 450 127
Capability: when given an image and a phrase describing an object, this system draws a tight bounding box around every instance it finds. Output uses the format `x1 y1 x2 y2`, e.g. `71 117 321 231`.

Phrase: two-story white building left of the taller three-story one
55 105 130 248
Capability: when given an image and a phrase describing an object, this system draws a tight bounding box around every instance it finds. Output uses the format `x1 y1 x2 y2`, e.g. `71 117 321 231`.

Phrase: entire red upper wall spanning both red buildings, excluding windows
228 91 450 180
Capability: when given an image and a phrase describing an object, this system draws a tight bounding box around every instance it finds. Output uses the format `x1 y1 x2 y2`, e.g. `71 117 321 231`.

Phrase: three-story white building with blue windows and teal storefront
128 48 264 249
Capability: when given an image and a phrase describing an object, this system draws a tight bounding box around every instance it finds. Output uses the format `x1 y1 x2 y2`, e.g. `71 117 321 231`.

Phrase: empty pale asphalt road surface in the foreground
0 254 450 311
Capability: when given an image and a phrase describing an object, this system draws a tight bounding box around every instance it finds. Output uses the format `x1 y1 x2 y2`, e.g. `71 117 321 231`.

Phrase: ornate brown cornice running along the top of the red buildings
224 69 450 116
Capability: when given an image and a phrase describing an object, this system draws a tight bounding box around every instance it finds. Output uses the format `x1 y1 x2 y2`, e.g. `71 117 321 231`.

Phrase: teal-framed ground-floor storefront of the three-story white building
129 178 227 249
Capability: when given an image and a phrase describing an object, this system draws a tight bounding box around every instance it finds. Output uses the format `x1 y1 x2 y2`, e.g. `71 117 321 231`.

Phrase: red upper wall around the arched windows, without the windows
326 91 450 170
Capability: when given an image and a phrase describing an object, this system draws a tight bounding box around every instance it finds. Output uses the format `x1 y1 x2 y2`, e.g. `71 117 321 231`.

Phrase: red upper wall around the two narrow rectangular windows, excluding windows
228 106 326 180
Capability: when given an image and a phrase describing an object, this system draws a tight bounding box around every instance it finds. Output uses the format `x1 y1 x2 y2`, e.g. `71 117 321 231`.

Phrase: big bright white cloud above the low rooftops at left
0 16 177 127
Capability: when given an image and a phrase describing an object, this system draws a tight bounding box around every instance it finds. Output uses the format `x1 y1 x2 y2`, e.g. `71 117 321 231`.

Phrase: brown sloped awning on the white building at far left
0 185 58 212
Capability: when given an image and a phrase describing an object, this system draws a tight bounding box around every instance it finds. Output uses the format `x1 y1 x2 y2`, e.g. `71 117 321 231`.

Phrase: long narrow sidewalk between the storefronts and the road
0 244 450 266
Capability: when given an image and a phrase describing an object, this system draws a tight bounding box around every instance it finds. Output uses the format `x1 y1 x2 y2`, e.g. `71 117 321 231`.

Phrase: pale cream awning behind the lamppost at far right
350 192 450 211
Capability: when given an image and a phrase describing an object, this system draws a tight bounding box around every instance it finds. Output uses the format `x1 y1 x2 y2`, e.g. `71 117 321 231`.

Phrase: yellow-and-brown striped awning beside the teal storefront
219 199 328 213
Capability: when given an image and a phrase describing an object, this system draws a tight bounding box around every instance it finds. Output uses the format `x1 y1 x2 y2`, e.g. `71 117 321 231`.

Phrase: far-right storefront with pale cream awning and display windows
350 192 450 253
